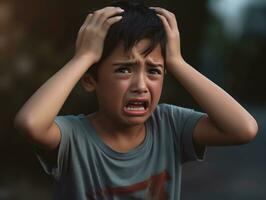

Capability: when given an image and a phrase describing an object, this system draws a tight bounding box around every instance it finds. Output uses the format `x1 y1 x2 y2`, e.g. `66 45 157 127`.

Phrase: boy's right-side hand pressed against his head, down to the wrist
150 7 184 72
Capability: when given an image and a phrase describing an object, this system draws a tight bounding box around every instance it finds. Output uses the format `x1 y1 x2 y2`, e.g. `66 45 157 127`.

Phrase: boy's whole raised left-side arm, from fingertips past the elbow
14 7 122 149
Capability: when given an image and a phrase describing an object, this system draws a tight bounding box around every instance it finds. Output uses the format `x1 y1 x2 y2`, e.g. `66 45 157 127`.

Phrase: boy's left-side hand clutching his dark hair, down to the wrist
75 7 123 63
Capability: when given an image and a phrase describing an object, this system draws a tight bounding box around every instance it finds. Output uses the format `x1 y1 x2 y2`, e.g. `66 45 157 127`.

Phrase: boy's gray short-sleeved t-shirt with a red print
37 104 206 200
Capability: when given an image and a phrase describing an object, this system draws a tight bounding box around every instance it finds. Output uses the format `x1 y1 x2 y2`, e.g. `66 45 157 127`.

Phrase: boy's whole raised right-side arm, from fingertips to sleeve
153 7 258 148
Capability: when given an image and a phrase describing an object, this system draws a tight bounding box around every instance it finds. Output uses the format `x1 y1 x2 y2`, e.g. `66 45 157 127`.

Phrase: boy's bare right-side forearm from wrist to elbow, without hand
168 60 257 133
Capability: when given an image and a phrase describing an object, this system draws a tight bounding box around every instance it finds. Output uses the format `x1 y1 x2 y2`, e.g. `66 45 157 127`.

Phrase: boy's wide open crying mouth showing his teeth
124 99 149 113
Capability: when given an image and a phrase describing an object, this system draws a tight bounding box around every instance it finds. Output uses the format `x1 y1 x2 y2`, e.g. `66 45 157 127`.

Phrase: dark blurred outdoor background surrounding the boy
0 0 266 200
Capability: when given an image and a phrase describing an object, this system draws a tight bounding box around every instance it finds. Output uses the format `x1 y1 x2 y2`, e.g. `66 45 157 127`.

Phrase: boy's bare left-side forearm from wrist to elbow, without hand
15 57 92 130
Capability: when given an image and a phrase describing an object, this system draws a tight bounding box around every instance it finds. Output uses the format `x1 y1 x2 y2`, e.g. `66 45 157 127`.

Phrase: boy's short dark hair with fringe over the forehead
88 1 166 80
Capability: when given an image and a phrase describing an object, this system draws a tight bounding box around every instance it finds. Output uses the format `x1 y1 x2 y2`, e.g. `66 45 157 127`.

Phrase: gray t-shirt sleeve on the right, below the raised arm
162 105 207 163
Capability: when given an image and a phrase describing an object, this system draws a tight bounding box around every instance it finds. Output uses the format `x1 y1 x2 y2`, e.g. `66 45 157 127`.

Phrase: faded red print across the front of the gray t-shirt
87 170 171 200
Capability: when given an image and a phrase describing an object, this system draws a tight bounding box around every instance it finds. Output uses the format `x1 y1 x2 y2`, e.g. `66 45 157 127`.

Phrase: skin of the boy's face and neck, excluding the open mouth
83 40 164 151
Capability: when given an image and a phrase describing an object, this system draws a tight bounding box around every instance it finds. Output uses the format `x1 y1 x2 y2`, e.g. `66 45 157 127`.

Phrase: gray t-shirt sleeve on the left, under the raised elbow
35 115 74 180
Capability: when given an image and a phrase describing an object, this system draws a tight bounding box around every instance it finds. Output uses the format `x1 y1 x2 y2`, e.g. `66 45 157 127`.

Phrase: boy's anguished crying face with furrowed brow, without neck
95 39 164 126
